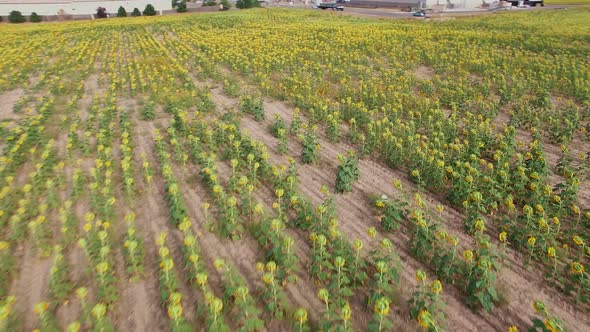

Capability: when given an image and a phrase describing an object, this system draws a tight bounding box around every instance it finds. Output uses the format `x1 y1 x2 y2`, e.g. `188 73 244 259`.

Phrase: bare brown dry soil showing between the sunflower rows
0 60 590 331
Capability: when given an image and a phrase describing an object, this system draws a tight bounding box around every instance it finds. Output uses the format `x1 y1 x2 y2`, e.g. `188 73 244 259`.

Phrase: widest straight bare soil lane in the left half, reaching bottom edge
122 112 187 331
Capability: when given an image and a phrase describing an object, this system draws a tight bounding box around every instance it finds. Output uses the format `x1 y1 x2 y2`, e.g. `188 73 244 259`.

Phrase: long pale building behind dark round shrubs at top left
0 0 172 17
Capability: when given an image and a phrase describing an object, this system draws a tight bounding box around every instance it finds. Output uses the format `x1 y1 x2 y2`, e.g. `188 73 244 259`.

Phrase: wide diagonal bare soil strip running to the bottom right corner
241 93 589 331
